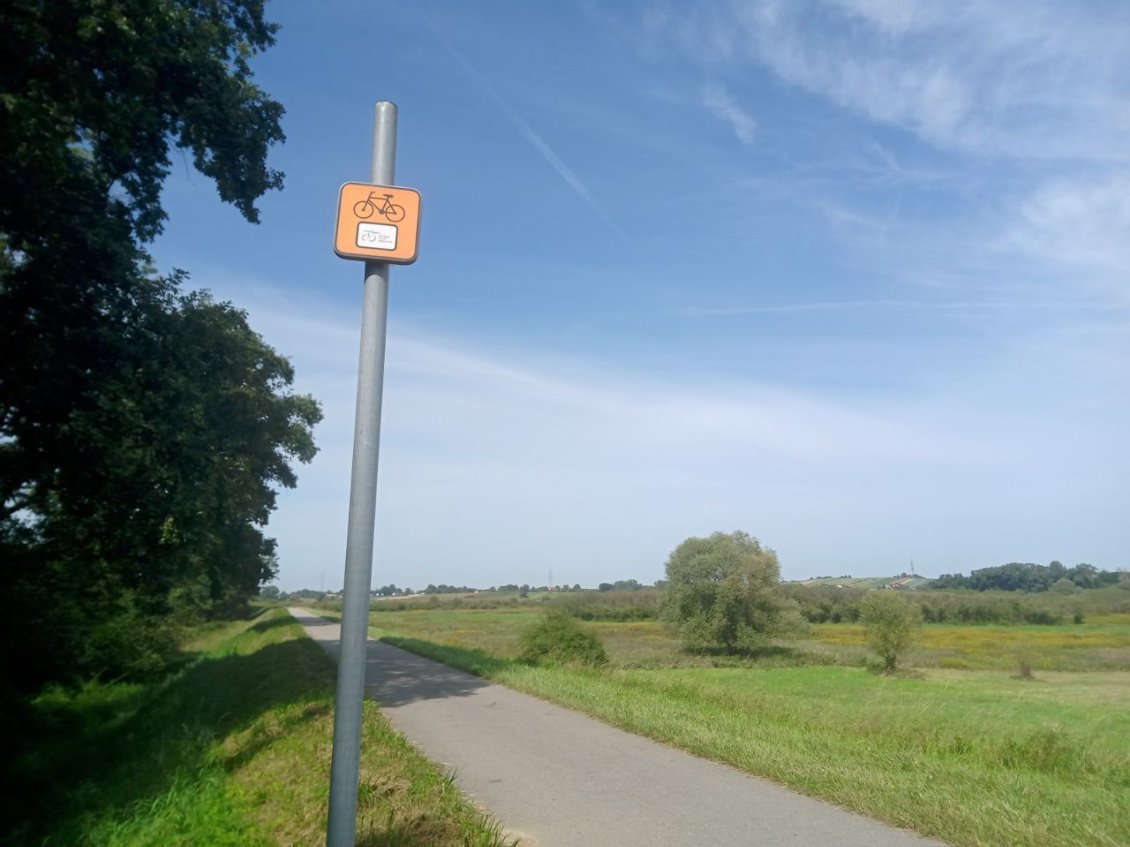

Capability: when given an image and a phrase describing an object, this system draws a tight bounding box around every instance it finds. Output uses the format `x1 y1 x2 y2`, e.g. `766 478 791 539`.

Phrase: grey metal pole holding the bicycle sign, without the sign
325 101 397 847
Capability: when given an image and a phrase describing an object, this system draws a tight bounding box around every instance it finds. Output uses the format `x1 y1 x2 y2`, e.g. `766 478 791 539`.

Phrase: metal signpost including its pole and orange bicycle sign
327 102 420 847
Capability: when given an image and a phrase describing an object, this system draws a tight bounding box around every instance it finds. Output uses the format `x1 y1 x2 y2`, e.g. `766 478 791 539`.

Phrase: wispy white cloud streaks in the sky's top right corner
645 0 1130 161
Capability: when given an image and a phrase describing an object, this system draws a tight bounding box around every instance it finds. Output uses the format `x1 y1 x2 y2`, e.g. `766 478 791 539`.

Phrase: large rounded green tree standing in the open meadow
661 531 803 652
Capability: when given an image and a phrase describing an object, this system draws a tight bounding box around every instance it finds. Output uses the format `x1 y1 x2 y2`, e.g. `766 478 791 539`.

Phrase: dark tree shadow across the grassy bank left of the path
0 618 333 845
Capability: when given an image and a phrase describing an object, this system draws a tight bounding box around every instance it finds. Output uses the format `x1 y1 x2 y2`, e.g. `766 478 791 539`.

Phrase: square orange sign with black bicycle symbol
333 182 420 264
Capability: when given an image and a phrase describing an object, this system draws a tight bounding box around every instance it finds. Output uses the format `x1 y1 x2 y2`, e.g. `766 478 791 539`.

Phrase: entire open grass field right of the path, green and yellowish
361 606 1130 847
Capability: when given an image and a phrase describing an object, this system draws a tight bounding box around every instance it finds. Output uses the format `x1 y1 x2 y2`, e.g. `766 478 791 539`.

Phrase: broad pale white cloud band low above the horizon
196 276 1130 588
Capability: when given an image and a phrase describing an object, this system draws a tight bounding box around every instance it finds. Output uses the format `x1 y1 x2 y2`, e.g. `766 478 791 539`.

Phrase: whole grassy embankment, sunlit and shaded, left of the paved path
0 609 504 847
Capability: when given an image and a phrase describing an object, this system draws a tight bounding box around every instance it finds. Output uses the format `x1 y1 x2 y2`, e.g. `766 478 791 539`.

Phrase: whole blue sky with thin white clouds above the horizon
154 0 1130 590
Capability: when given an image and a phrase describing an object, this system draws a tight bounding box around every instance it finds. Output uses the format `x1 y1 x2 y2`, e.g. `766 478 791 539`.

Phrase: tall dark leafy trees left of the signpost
0 0 320 693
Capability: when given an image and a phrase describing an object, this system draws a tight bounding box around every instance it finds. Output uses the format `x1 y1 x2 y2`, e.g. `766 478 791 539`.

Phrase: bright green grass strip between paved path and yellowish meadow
374 614 1130 847
